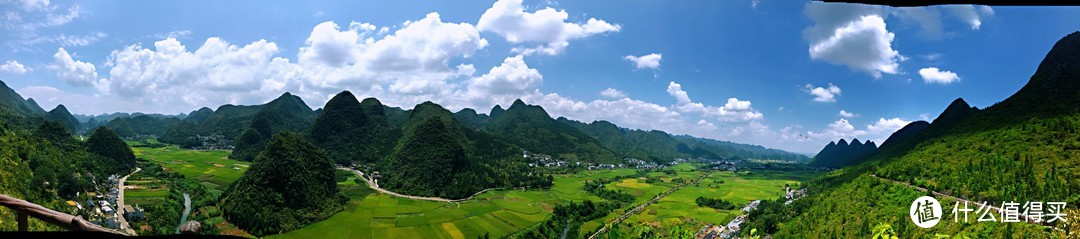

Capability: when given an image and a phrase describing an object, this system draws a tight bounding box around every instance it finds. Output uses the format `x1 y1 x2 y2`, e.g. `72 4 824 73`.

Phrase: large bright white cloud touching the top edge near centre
476 0 621 55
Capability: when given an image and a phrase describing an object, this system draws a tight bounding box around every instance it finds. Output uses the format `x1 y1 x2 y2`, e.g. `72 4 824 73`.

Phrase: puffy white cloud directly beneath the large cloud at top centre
469 55 543 95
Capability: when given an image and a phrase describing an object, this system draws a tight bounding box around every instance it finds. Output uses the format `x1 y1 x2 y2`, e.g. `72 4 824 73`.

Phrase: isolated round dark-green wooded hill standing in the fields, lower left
221 132 347 236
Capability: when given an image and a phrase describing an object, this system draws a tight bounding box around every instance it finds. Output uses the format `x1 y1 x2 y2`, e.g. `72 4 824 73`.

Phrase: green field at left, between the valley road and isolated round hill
132 146 251 190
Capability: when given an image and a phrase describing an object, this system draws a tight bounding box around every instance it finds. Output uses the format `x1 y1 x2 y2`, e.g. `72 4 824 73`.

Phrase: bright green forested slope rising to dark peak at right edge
751 32 1080 238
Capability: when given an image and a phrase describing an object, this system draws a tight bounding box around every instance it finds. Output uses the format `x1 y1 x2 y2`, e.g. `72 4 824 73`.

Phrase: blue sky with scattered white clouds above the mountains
0 0 1080 154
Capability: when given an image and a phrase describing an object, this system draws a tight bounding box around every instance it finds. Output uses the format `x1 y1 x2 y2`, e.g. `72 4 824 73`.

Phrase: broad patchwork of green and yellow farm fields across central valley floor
270 164 815 238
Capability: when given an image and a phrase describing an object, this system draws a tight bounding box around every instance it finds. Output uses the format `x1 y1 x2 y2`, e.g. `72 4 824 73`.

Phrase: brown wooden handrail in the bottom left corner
0 195 122 235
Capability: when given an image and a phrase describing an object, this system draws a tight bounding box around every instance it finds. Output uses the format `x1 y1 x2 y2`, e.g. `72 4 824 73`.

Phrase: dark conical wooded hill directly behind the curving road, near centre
379 102 551 198
